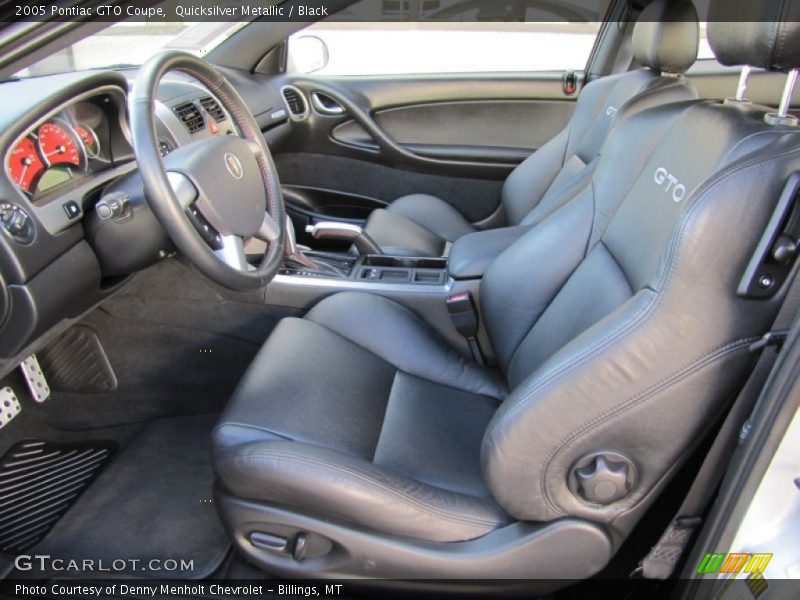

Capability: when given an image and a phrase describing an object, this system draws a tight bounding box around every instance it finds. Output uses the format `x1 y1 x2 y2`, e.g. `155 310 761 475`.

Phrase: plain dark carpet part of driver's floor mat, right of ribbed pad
35 415 230 579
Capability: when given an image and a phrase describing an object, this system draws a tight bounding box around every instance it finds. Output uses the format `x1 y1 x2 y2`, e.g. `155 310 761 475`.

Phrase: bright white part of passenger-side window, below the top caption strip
288 22 599 75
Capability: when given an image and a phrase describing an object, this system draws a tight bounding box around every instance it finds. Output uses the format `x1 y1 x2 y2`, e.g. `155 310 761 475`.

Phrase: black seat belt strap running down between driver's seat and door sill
631 267 800 580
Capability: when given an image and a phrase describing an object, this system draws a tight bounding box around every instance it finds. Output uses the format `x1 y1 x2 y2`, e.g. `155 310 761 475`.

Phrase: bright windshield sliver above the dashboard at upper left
16 21 247 77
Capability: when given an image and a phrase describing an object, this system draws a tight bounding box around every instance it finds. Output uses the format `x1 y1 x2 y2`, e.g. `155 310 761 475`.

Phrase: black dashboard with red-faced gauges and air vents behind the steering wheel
0 70 291 375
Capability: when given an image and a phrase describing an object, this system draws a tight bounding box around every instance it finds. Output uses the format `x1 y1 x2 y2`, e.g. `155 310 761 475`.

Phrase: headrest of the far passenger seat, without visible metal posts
633 0 700 73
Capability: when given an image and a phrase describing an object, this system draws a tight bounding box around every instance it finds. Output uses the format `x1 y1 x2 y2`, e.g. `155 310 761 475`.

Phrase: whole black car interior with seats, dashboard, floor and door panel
0 0 800 598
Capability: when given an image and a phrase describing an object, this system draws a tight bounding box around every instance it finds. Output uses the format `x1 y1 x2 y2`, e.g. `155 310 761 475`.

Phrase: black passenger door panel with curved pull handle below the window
274 72 576 221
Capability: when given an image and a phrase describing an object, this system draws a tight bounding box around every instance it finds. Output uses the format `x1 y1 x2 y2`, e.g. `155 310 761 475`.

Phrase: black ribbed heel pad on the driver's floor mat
0 440 116 553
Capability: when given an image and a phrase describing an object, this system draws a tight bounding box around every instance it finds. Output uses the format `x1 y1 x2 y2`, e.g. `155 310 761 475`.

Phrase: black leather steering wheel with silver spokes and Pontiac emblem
129 51 286 291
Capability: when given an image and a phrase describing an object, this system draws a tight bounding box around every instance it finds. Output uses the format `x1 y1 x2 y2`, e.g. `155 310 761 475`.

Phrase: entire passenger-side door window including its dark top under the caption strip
288 0 605 75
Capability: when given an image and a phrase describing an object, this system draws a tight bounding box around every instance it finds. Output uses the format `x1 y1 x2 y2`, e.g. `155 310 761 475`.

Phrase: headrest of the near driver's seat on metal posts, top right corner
708 0 800 71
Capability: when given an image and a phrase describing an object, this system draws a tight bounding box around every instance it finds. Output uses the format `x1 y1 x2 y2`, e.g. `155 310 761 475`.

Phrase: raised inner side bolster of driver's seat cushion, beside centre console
306 292 508 400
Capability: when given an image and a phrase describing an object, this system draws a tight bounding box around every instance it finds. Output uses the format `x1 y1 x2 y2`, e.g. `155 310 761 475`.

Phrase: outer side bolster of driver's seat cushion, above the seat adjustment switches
216 441 510 542
